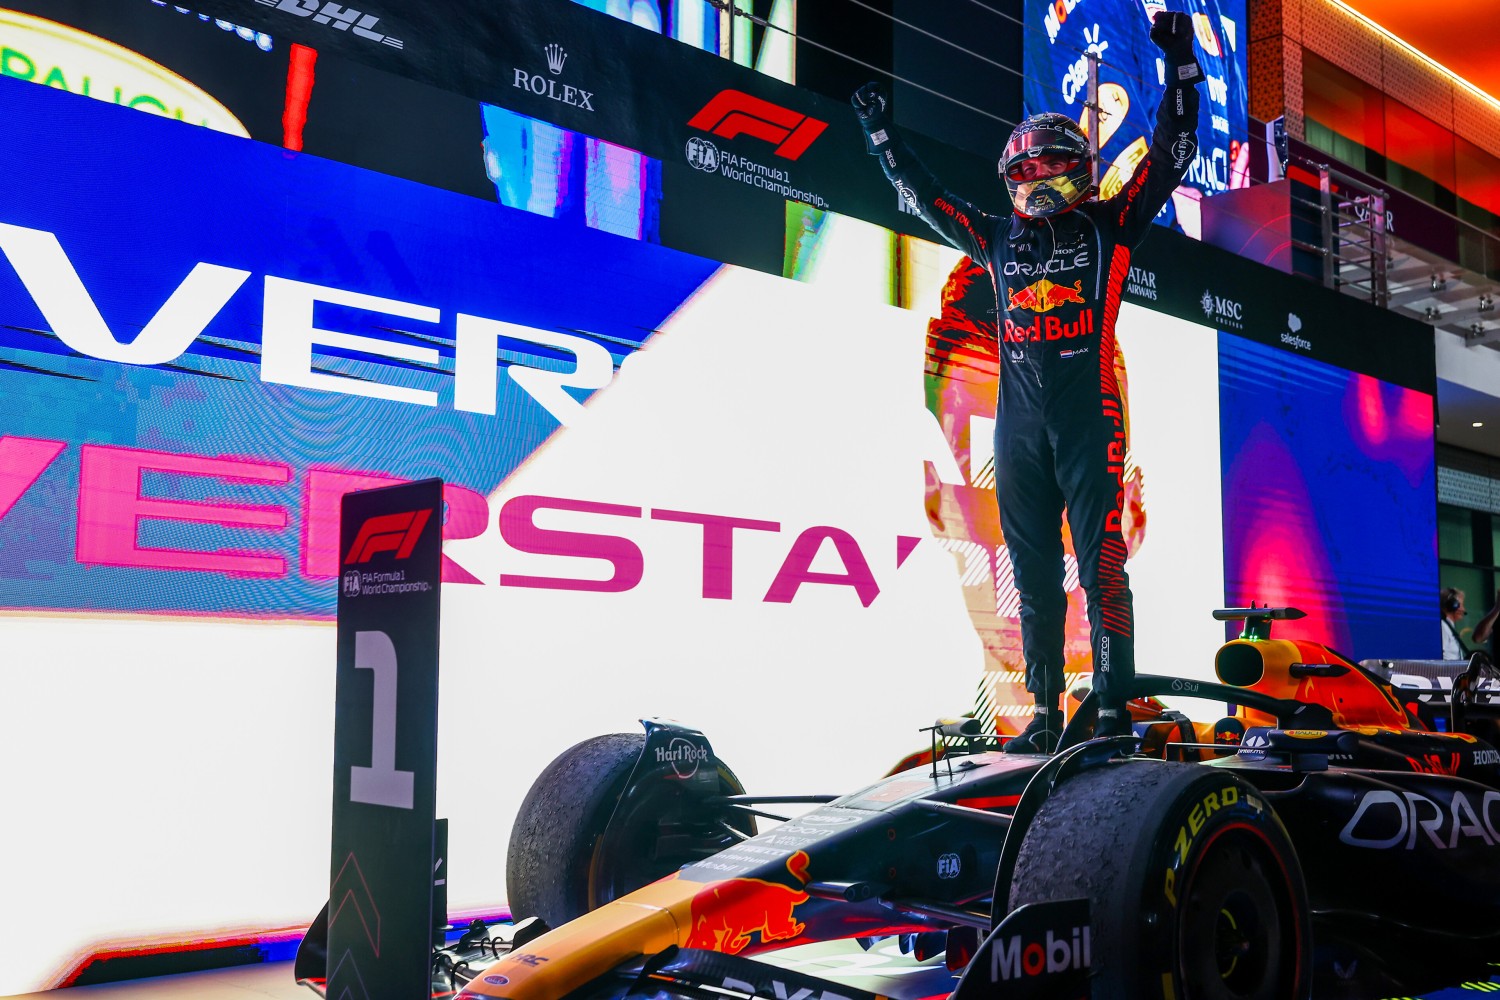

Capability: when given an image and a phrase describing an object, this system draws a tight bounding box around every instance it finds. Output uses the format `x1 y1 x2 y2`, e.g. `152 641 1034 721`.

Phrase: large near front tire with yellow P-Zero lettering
1010 759 1313 1000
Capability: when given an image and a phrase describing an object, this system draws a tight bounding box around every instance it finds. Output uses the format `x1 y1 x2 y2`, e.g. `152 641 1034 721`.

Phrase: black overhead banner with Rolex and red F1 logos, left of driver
170 0 1004 238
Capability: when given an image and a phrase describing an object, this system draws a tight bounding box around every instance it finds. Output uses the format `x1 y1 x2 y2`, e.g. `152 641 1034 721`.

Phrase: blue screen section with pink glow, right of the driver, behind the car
1220 333 1440 660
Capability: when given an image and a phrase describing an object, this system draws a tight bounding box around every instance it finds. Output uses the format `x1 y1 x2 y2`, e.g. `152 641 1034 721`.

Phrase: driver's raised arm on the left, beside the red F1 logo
851 84 995 267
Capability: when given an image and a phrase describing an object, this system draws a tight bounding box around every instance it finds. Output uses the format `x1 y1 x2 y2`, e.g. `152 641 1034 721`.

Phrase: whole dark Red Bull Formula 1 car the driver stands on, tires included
299 607 1500 1000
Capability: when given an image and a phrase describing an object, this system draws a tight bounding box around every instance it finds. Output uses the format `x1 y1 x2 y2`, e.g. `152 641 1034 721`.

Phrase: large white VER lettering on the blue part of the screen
0 223 615 426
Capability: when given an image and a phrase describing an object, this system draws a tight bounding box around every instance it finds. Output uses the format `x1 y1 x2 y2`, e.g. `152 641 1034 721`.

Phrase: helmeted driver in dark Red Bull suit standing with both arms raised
854 10 1203 753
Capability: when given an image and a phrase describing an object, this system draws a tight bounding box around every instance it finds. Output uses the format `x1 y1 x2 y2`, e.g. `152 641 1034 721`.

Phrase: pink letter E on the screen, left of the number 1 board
77 444 291 577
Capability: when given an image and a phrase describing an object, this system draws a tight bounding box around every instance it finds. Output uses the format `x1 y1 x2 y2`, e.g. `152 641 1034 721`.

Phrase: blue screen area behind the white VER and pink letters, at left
0 79 717 618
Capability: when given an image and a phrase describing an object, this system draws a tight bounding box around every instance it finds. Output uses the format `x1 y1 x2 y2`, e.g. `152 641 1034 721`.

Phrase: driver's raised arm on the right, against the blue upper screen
1106 10 1203 244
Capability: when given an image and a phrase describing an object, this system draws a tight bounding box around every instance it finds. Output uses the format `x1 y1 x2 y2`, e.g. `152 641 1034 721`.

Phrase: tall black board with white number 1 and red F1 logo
327 480 446 1000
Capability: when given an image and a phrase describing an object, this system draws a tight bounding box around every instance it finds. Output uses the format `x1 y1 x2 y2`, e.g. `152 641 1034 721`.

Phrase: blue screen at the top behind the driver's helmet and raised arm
1023 0 1250 230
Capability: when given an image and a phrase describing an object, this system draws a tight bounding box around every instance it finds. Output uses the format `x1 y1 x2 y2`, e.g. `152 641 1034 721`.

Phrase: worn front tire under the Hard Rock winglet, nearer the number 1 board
506 733 755 927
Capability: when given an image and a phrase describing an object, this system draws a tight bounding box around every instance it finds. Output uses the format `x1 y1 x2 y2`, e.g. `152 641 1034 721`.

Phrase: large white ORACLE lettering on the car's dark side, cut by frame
1338 789 1500 850
